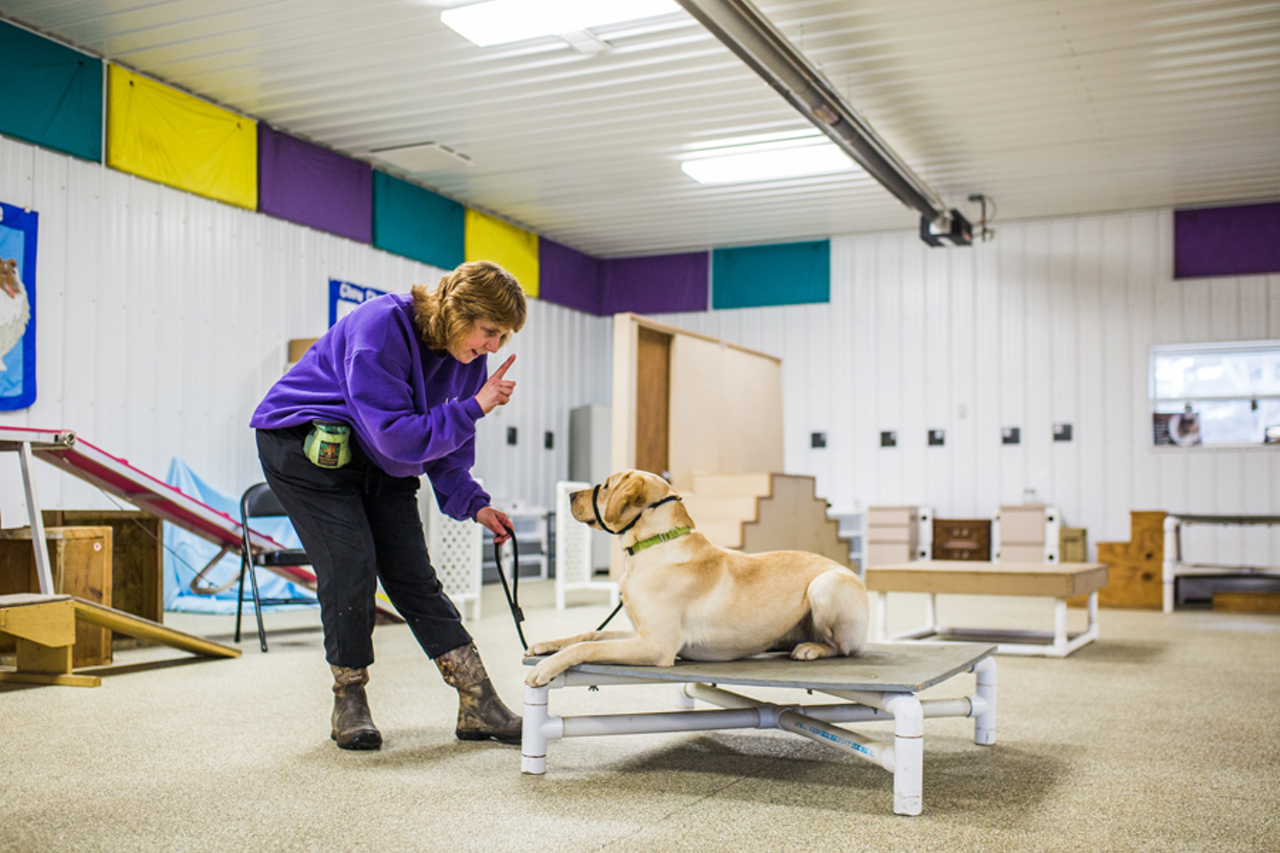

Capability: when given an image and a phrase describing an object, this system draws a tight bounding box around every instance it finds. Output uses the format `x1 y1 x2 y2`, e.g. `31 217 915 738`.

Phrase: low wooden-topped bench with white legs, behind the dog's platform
865 560 1107 657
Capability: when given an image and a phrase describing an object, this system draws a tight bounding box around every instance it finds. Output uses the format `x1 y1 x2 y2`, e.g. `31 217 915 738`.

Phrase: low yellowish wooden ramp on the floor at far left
0 593 241 686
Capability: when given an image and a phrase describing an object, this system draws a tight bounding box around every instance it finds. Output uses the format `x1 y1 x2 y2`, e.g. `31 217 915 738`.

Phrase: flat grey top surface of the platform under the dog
525 643 996 693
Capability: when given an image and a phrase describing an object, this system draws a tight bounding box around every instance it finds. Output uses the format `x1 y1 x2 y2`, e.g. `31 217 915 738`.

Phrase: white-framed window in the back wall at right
1151 341 1280 446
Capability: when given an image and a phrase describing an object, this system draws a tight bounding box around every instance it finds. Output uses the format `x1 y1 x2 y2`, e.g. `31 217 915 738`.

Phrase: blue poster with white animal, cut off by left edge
0 204 40 411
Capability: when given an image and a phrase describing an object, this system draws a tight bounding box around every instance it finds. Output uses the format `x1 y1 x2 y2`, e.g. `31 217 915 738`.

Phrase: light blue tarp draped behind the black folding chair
164 459 315 613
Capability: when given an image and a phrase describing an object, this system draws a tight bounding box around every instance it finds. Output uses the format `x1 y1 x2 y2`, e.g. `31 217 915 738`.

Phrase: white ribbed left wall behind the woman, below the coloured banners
0 138 612 526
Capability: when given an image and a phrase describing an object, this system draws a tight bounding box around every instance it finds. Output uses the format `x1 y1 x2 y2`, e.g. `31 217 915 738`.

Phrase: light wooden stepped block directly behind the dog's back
682 473 850 566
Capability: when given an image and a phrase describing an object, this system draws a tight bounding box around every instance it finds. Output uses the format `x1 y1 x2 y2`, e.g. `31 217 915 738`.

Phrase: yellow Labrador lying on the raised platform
525 471 868 686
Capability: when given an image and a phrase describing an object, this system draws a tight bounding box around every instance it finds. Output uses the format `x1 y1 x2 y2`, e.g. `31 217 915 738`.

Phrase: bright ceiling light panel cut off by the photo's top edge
440 0 680 47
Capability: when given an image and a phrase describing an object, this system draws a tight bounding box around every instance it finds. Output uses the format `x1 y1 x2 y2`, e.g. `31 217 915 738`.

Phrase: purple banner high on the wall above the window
1174 202 1280 278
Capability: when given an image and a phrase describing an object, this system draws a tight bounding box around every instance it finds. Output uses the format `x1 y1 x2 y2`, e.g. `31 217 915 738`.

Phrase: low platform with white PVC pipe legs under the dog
521 643 996 815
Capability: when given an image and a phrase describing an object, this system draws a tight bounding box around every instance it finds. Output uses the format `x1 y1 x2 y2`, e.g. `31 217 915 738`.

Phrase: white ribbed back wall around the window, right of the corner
662 211 1280 565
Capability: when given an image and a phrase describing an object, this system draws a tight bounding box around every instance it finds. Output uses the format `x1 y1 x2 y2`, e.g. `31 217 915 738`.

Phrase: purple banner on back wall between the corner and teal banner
600 252 710 314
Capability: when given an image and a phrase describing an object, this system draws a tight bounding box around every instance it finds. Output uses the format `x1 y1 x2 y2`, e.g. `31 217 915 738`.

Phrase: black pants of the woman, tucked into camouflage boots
257 425 471 667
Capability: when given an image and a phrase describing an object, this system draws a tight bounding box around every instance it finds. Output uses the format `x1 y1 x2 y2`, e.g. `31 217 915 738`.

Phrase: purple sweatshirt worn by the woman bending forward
250 293 489 519
